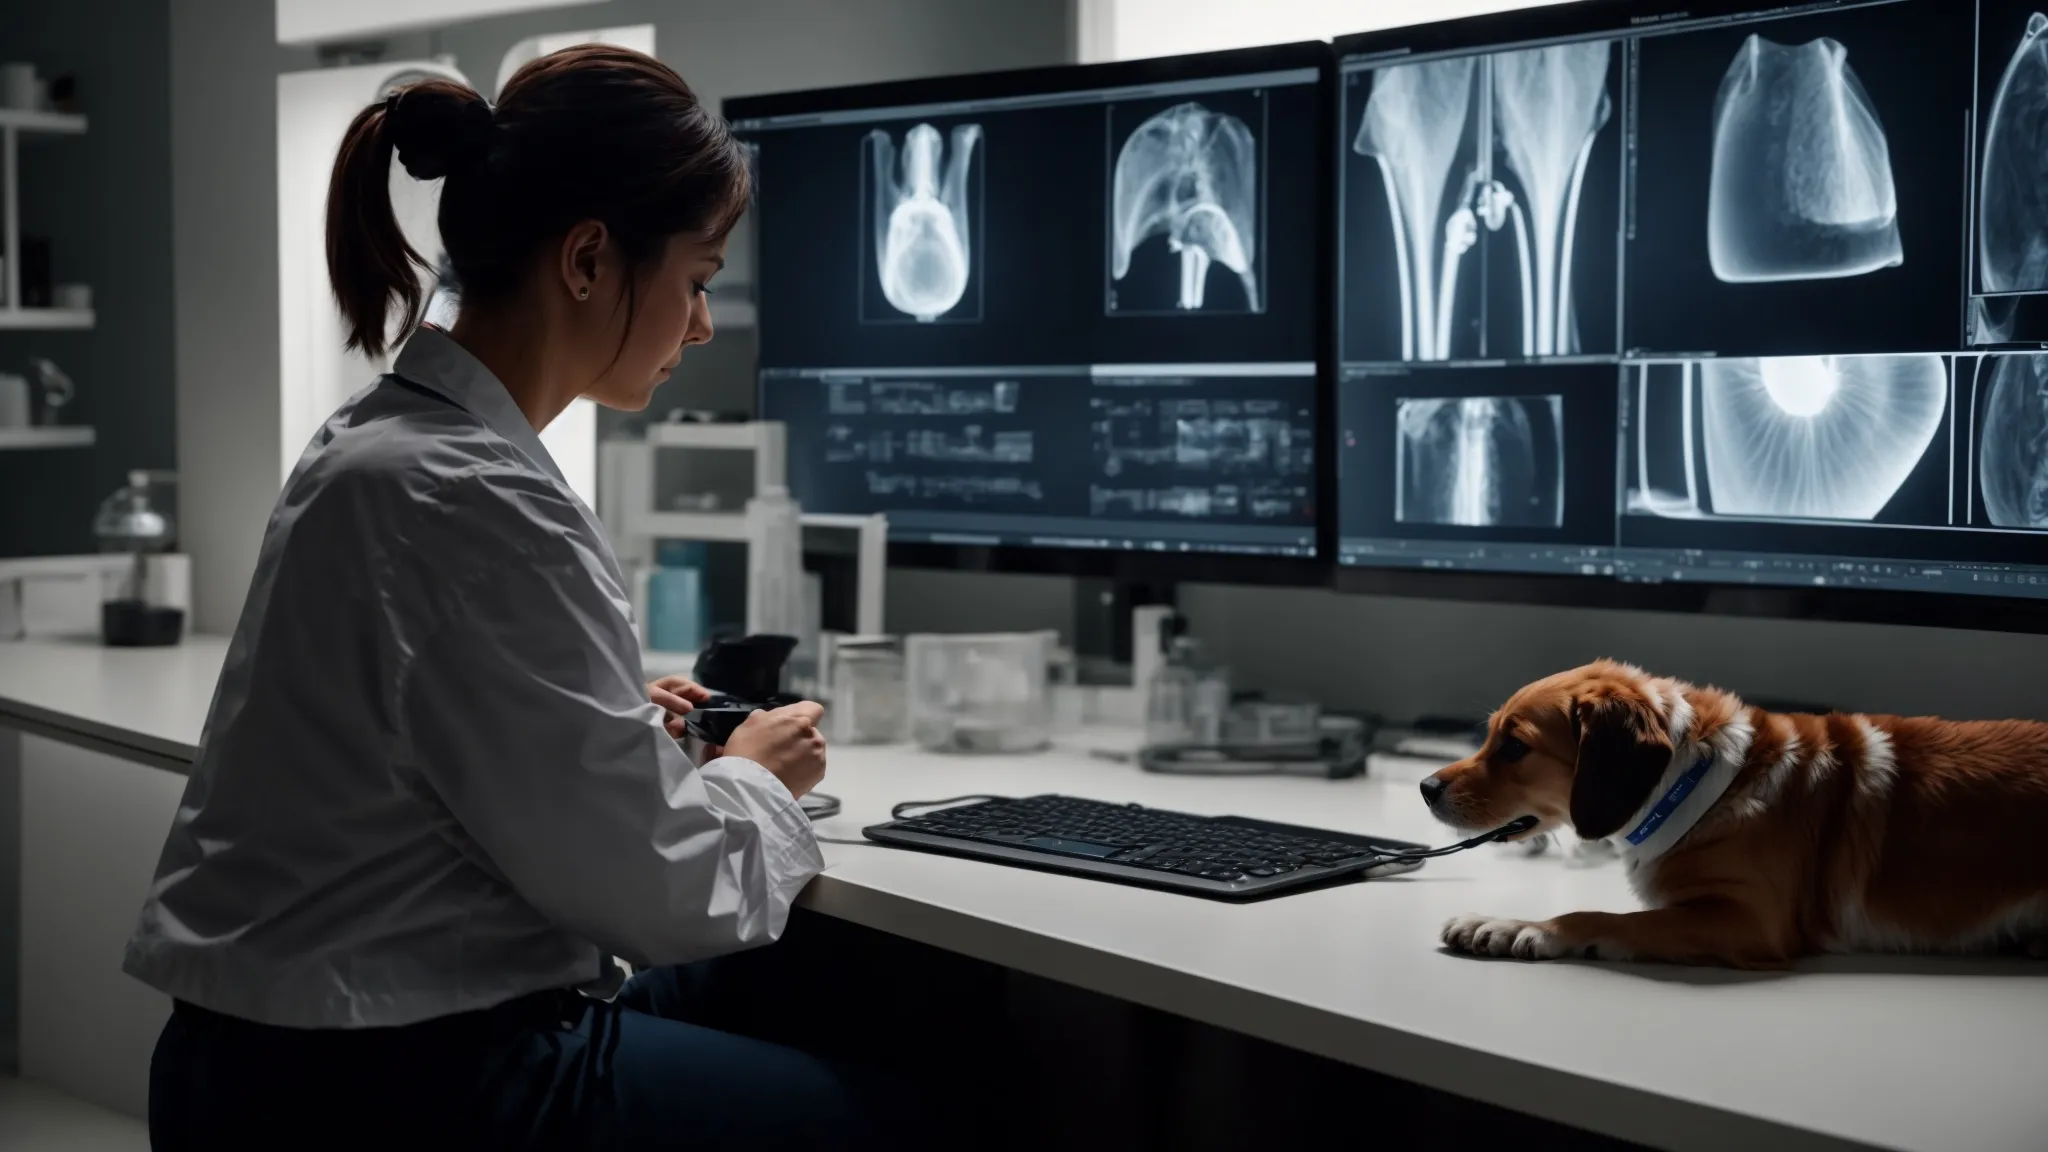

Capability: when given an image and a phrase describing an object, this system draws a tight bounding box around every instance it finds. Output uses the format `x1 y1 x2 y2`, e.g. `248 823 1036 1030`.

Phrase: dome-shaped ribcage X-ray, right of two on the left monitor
1110 100 1264 314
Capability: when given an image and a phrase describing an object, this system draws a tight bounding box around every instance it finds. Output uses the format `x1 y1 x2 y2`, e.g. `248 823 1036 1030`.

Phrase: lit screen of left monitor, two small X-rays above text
725 43 1333 582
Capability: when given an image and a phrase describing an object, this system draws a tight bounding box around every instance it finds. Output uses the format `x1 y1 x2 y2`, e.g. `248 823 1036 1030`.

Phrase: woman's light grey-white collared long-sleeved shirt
123 328 823 1027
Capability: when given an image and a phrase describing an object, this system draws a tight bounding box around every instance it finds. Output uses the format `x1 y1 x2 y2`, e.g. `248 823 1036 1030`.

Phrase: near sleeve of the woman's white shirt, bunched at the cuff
397 471 823 965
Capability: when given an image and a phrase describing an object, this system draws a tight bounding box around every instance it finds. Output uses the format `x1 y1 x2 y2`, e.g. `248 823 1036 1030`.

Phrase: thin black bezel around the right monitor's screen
1329 0 2048 633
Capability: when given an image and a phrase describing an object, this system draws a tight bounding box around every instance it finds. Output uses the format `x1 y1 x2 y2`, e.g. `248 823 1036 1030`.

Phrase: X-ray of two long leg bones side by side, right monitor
1352 43 1614 361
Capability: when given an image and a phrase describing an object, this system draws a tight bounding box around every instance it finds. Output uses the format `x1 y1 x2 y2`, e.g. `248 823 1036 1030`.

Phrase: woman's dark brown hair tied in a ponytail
328 45 752 357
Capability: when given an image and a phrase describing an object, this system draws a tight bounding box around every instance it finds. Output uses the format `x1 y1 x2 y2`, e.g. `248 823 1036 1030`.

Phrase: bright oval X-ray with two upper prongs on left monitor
866 123 981 324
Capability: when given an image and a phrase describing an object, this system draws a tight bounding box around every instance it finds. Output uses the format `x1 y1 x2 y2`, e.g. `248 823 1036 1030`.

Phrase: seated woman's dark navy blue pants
150 918 958 1152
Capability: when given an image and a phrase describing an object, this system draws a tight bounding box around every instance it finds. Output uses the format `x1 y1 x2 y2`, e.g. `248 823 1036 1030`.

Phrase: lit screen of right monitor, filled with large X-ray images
1335 0 2048 629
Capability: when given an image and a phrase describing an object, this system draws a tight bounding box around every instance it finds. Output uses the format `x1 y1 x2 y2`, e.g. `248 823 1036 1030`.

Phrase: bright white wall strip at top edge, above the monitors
1077 0 1581 61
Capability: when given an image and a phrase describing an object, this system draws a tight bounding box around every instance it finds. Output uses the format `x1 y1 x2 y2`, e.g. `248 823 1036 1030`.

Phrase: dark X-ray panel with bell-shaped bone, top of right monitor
1622 2 1972 359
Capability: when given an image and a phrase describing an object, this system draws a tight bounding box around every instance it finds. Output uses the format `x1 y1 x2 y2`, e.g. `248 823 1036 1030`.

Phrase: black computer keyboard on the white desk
864 795 1423 898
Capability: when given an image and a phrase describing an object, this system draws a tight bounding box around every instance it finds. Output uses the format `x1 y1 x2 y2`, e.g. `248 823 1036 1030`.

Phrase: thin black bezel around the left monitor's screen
721 41 1337 586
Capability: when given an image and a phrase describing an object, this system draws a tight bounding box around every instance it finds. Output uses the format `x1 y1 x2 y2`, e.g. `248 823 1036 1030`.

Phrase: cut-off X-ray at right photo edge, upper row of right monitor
1976 12 2048 293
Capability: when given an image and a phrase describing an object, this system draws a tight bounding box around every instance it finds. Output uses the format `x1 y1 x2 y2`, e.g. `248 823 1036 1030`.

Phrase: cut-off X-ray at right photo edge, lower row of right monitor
1970 353 2048 531
